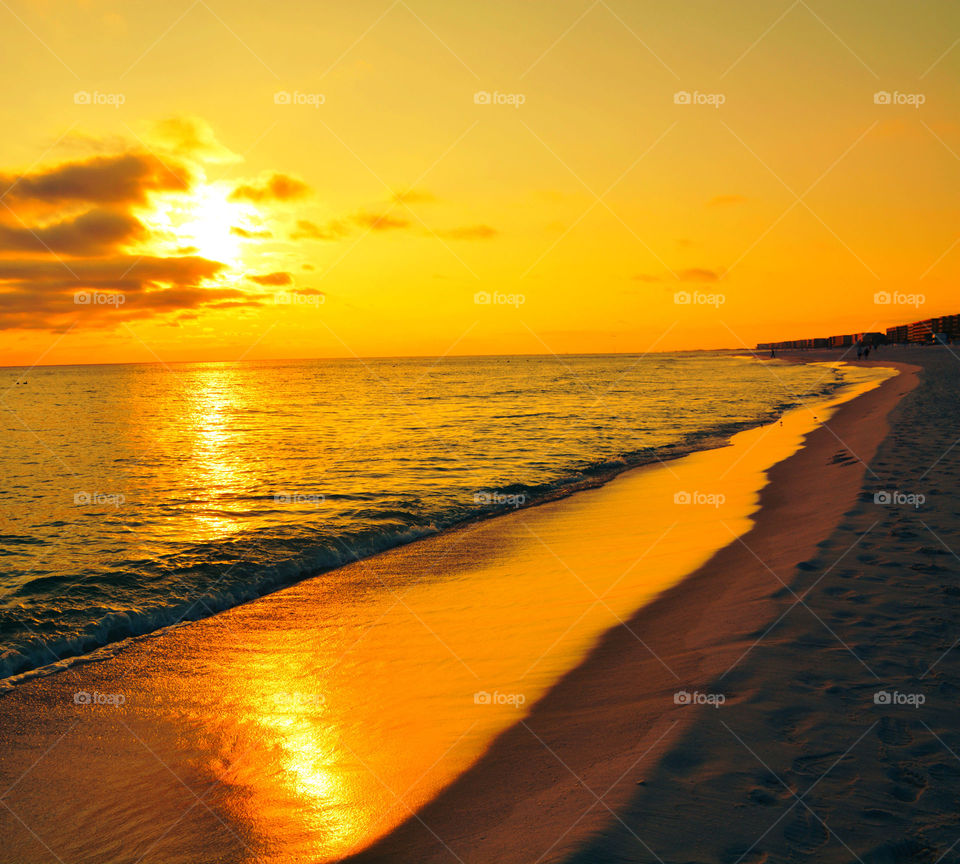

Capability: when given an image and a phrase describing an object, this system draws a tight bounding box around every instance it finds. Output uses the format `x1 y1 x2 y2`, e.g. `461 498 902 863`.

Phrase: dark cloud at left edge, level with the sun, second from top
0 209 148 256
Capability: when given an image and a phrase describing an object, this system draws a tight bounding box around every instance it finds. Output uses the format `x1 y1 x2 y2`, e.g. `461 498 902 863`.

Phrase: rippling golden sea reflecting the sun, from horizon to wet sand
0 353 841 678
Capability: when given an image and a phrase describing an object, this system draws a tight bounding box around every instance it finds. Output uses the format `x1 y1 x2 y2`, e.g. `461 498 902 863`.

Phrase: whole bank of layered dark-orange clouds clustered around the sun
0 125 318 332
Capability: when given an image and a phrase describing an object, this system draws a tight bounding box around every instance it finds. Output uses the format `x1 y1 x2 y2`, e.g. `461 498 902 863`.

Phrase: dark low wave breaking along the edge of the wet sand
0 379 842 691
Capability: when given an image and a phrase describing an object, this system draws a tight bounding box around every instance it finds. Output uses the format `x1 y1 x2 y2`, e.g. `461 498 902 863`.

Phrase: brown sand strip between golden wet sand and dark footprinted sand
348 352 921 864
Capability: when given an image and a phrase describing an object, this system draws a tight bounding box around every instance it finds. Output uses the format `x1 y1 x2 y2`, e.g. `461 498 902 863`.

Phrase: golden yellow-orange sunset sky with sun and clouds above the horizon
0 0 960 365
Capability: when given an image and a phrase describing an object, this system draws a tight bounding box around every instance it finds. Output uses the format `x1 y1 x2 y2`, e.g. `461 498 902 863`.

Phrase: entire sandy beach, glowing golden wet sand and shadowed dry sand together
0 350 960 862
